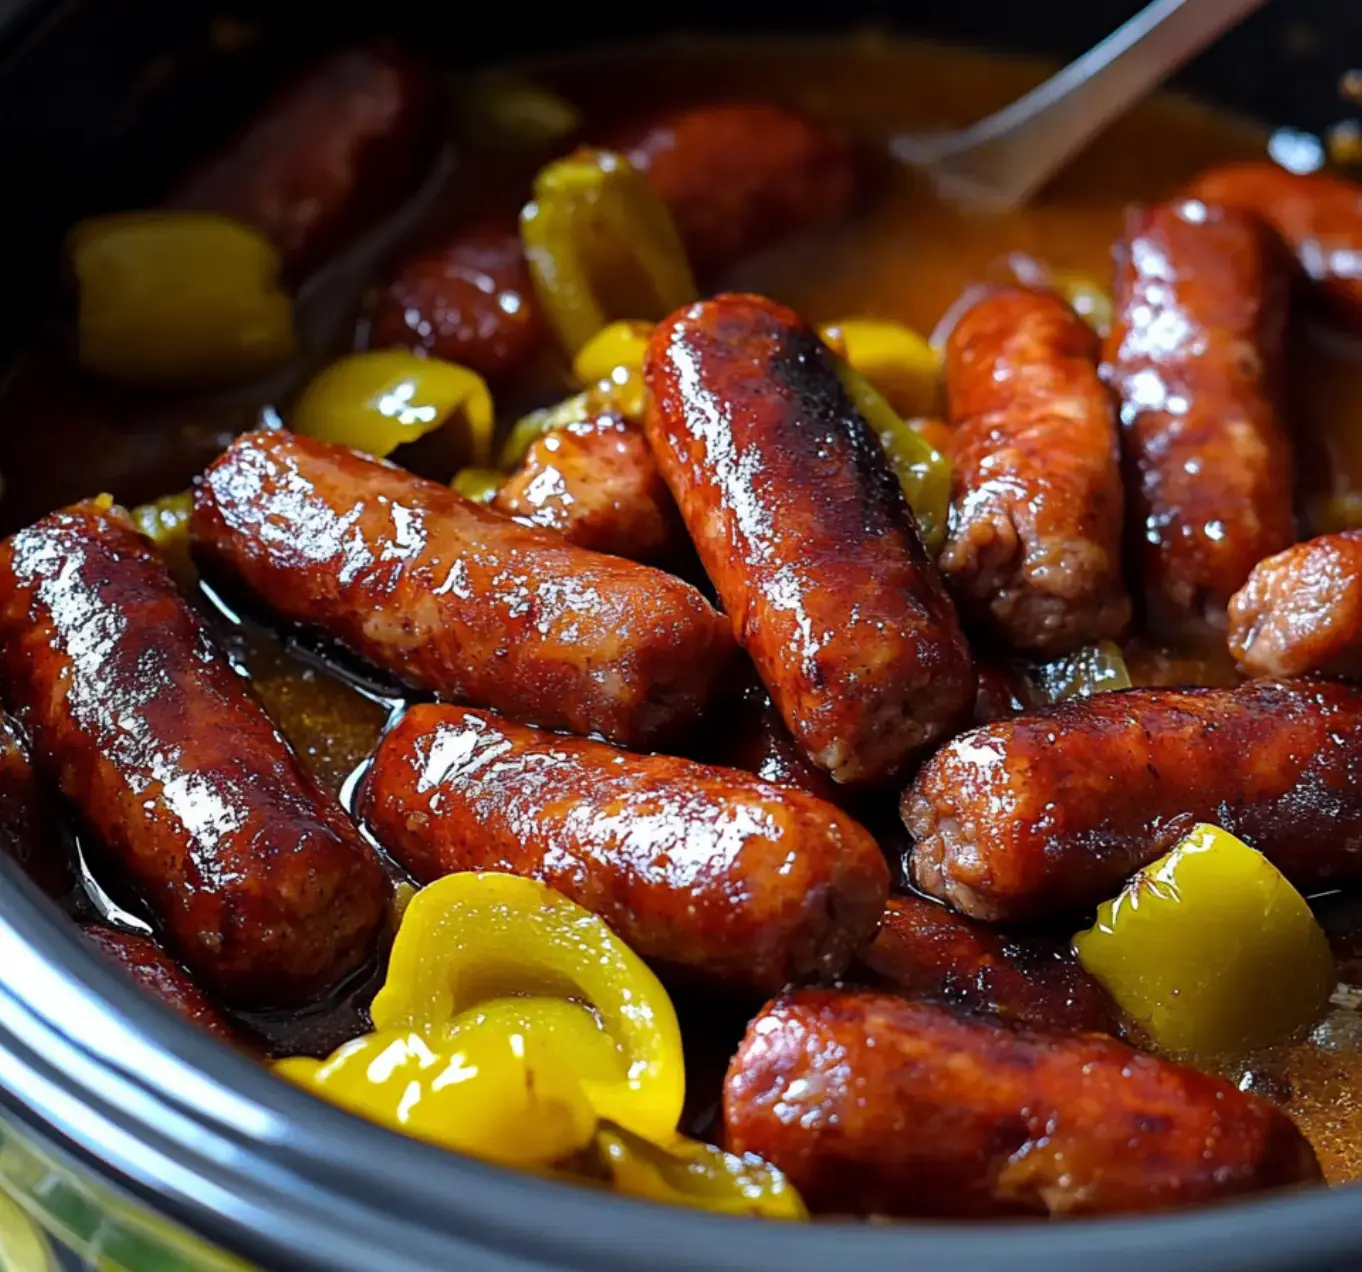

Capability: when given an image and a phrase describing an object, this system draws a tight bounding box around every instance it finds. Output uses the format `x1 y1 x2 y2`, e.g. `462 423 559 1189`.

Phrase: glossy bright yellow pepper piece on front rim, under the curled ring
275 1028 597 1166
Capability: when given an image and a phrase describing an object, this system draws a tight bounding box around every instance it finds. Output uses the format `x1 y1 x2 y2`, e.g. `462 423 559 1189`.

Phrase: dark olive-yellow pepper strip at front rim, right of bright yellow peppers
595 1122 809 1219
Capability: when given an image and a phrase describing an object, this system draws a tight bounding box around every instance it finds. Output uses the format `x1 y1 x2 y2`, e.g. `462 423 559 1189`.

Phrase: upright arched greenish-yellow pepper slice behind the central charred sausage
520 150 697 354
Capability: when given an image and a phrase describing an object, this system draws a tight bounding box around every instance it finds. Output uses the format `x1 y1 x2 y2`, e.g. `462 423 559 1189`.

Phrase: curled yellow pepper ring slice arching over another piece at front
370 873 685 1137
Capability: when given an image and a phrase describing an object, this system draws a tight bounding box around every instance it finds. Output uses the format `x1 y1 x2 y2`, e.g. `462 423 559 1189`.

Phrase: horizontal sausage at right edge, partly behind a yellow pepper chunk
900 681 1362 921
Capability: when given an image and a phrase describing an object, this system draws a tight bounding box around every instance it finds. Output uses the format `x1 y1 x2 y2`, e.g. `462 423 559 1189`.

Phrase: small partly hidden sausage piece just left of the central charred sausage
492 413 686 561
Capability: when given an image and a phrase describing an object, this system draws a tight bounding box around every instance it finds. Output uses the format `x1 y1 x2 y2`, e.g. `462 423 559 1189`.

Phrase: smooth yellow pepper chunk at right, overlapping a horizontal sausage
1073 825 1335 1057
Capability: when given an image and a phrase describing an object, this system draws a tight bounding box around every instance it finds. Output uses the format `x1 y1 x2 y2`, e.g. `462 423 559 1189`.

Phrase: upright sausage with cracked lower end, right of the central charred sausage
938 287 1130 654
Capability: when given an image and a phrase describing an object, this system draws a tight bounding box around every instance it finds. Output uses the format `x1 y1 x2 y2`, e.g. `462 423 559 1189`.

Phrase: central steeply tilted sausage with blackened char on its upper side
644 296 974 783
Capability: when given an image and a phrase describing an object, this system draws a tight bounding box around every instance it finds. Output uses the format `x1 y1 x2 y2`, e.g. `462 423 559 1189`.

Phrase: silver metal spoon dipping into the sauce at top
893 0 1264 210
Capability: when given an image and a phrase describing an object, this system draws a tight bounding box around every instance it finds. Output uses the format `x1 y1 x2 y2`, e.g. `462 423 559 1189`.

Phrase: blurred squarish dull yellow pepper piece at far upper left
67 211 297 388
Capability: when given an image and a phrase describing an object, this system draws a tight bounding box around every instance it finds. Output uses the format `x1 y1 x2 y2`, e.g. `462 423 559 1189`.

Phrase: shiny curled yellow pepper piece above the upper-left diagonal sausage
289 349 493 464
